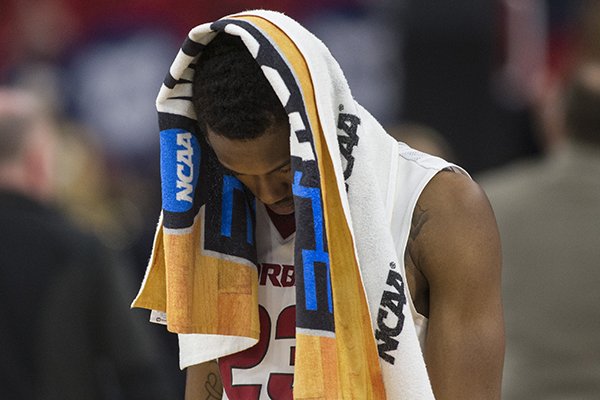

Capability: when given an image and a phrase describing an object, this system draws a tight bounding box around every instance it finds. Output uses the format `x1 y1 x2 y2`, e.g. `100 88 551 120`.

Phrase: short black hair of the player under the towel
192 33 288 140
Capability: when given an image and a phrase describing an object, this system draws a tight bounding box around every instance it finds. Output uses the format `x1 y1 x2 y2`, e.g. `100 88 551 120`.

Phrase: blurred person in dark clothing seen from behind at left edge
0 89 172 400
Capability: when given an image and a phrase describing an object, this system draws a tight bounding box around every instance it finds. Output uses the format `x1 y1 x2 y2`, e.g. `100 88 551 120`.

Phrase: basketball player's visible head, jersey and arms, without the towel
181 33 504 400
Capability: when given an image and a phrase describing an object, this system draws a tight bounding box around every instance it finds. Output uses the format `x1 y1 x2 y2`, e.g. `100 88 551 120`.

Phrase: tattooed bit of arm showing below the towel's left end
185 361 223 400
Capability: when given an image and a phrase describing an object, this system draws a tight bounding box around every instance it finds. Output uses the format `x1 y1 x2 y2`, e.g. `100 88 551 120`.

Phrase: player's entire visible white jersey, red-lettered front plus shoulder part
180 143 466 400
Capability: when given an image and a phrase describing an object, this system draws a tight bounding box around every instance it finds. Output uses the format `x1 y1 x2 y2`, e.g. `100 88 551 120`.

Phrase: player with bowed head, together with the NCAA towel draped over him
133 11 504 400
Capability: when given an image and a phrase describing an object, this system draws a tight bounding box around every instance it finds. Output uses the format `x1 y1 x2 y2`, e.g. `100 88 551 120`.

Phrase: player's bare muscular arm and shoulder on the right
409 172 504 400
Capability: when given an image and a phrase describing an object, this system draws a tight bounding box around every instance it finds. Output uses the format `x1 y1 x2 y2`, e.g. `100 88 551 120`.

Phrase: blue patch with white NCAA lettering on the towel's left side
160 128 200 212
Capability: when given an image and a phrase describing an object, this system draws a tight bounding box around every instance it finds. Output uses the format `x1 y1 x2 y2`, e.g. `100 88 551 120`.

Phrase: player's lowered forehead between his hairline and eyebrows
207 128 290 175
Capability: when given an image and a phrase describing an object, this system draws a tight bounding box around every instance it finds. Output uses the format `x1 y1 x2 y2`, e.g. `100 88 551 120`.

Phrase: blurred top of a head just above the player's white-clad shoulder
387 123 458 164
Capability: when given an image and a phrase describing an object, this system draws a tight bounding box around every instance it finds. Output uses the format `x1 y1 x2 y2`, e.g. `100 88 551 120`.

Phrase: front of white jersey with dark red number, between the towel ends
219 203 296 400
